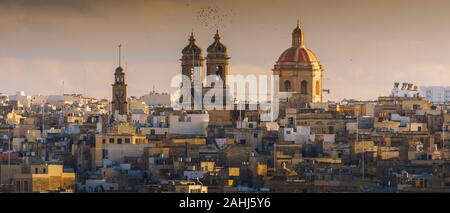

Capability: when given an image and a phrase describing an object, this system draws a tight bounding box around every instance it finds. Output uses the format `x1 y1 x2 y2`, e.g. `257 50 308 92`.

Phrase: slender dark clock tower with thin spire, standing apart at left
111 45 128 115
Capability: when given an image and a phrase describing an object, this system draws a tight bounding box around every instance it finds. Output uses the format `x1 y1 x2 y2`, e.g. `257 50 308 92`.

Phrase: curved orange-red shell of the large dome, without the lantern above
277 46 319 63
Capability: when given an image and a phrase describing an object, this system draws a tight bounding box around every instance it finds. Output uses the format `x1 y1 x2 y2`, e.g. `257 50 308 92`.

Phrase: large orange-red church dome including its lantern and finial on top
277 23 319 63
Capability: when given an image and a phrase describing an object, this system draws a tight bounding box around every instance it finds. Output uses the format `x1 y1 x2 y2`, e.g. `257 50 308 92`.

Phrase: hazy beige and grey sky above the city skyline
0 0 450 100
